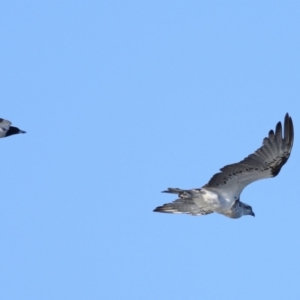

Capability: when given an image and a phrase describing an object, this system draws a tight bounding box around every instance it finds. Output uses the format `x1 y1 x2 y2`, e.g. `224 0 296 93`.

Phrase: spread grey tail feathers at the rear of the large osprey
153 188 213 216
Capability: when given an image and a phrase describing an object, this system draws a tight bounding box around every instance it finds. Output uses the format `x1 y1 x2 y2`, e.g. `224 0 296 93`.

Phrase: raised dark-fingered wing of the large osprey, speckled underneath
205 114 294 199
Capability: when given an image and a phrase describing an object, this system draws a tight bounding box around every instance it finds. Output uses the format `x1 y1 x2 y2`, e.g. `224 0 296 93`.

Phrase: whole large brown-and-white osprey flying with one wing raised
154 114 294 219
